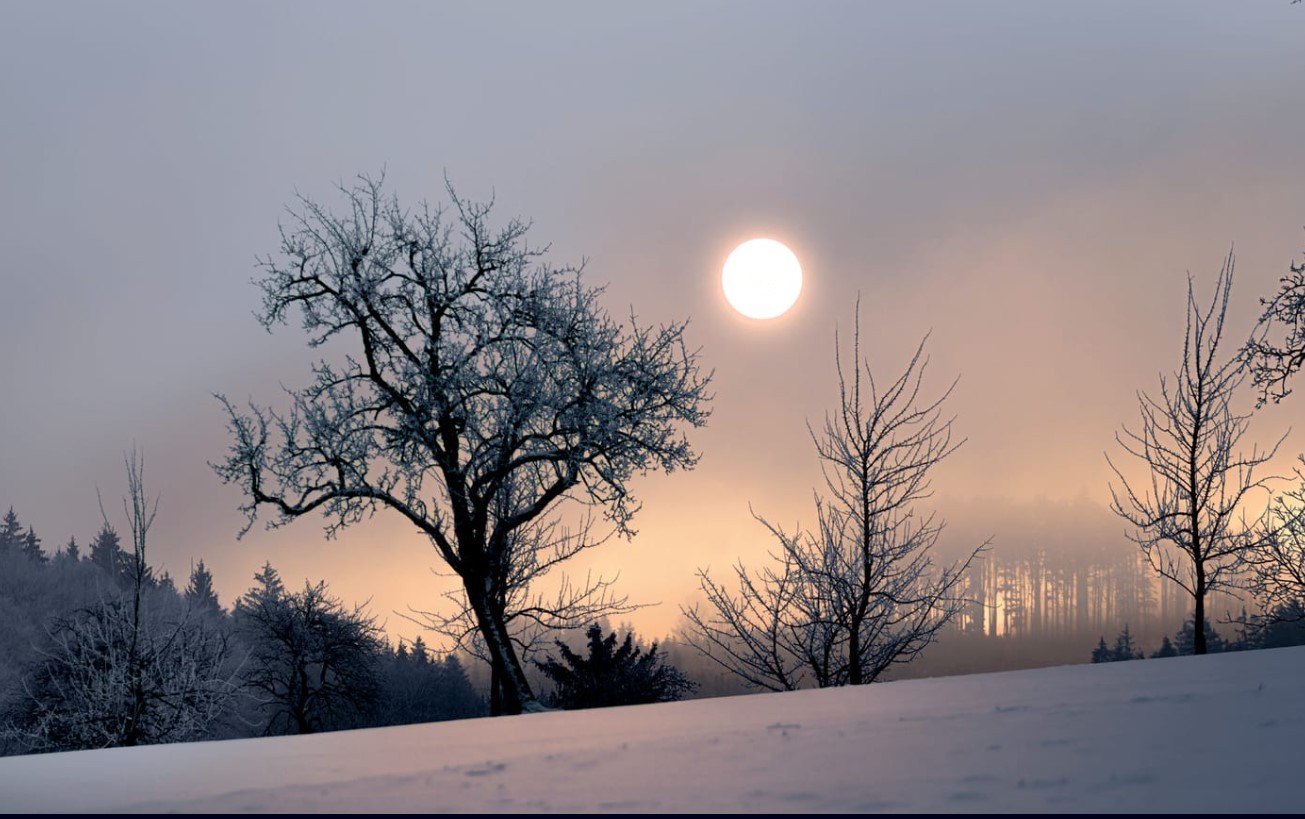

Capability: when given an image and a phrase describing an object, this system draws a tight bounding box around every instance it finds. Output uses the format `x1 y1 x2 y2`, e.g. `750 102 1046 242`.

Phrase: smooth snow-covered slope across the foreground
0 648 1305 812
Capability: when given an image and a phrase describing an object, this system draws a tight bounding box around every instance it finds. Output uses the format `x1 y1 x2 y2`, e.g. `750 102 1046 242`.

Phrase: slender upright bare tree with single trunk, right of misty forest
1107 254 1287 655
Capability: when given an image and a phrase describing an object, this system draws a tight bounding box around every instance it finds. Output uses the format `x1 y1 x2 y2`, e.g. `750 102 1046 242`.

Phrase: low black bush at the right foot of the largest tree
535 625 694 709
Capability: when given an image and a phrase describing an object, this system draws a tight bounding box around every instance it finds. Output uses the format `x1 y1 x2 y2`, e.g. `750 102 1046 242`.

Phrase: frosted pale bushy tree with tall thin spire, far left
10 450 235 751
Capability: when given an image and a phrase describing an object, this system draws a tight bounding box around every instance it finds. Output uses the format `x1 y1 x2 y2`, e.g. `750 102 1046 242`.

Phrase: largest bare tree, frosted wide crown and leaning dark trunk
214 179 710 712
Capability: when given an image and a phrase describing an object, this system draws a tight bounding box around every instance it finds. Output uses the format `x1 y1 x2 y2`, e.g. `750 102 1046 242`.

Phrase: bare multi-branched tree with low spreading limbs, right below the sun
684 305 987 690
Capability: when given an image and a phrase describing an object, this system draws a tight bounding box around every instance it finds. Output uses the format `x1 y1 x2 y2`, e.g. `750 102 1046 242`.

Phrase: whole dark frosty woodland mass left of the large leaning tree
0 474 485 754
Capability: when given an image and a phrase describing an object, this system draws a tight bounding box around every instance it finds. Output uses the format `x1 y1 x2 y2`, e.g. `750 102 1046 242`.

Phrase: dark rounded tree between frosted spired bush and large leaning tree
234 567 384 734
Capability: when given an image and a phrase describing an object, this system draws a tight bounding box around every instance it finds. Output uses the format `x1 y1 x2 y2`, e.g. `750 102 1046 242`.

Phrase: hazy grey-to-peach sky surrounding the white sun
0 0 1305 636
